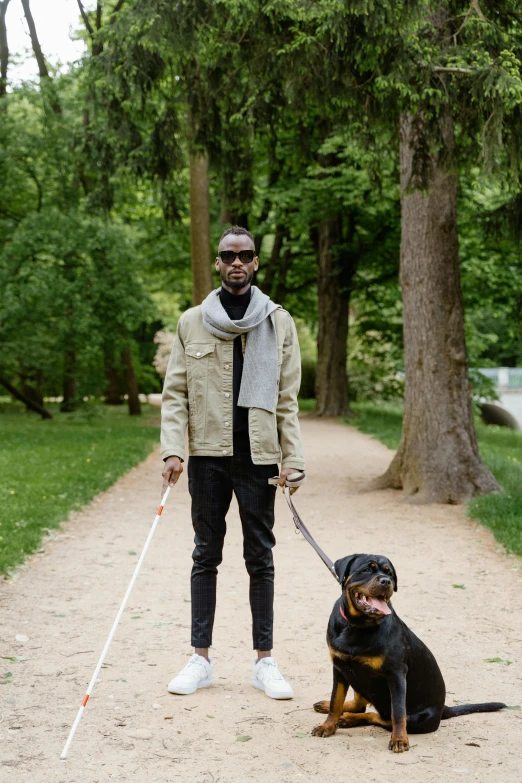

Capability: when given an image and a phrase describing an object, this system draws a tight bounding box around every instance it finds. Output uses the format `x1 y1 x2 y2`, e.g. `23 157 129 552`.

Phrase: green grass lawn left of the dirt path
0 403 159 574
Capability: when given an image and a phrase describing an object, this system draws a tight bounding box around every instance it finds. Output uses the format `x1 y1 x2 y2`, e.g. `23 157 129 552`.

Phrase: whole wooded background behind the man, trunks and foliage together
0 0 522 528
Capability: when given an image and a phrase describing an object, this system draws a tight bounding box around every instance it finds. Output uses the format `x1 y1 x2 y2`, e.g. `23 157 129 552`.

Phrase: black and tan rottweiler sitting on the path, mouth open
312 555 506 753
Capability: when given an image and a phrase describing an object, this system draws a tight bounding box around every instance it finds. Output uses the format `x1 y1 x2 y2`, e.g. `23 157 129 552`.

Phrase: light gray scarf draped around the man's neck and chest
201 285 281 413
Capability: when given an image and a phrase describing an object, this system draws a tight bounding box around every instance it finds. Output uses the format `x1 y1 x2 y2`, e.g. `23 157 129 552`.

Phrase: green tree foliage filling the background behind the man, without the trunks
0 0 522 426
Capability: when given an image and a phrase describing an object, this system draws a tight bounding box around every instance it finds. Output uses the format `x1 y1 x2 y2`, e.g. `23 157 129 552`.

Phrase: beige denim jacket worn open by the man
161 306 304 470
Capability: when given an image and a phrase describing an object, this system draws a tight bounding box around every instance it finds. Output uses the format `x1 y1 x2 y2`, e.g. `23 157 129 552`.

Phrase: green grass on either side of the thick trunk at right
345 403 522 555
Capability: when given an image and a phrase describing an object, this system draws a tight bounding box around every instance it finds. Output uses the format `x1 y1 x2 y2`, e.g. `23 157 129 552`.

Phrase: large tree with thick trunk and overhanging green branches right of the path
284 0 522 503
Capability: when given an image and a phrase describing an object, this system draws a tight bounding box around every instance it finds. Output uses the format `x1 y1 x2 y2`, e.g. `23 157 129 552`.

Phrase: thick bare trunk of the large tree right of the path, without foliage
376 115 498 503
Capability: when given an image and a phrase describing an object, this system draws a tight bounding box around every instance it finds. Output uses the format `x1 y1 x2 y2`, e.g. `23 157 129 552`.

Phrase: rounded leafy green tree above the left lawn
0 208 153 395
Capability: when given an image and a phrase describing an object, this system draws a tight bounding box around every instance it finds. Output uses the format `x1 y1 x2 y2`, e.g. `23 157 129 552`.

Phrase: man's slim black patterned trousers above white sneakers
188 453 278 650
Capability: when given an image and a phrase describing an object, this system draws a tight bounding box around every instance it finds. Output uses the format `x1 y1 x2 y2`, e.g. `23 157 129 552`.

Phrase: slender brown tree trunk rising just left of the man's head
190 152 212 305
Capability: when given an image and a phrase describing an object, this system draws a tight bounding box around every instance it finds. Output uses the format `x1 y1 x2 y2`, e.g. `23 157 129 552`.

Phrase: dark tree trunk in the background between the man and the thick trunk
315 215 352 416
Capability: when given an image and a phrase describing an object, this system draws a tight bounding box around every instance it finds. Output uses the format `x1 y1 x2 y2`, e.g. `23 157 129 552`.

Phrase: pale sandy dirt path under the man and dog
0 419 522 783
